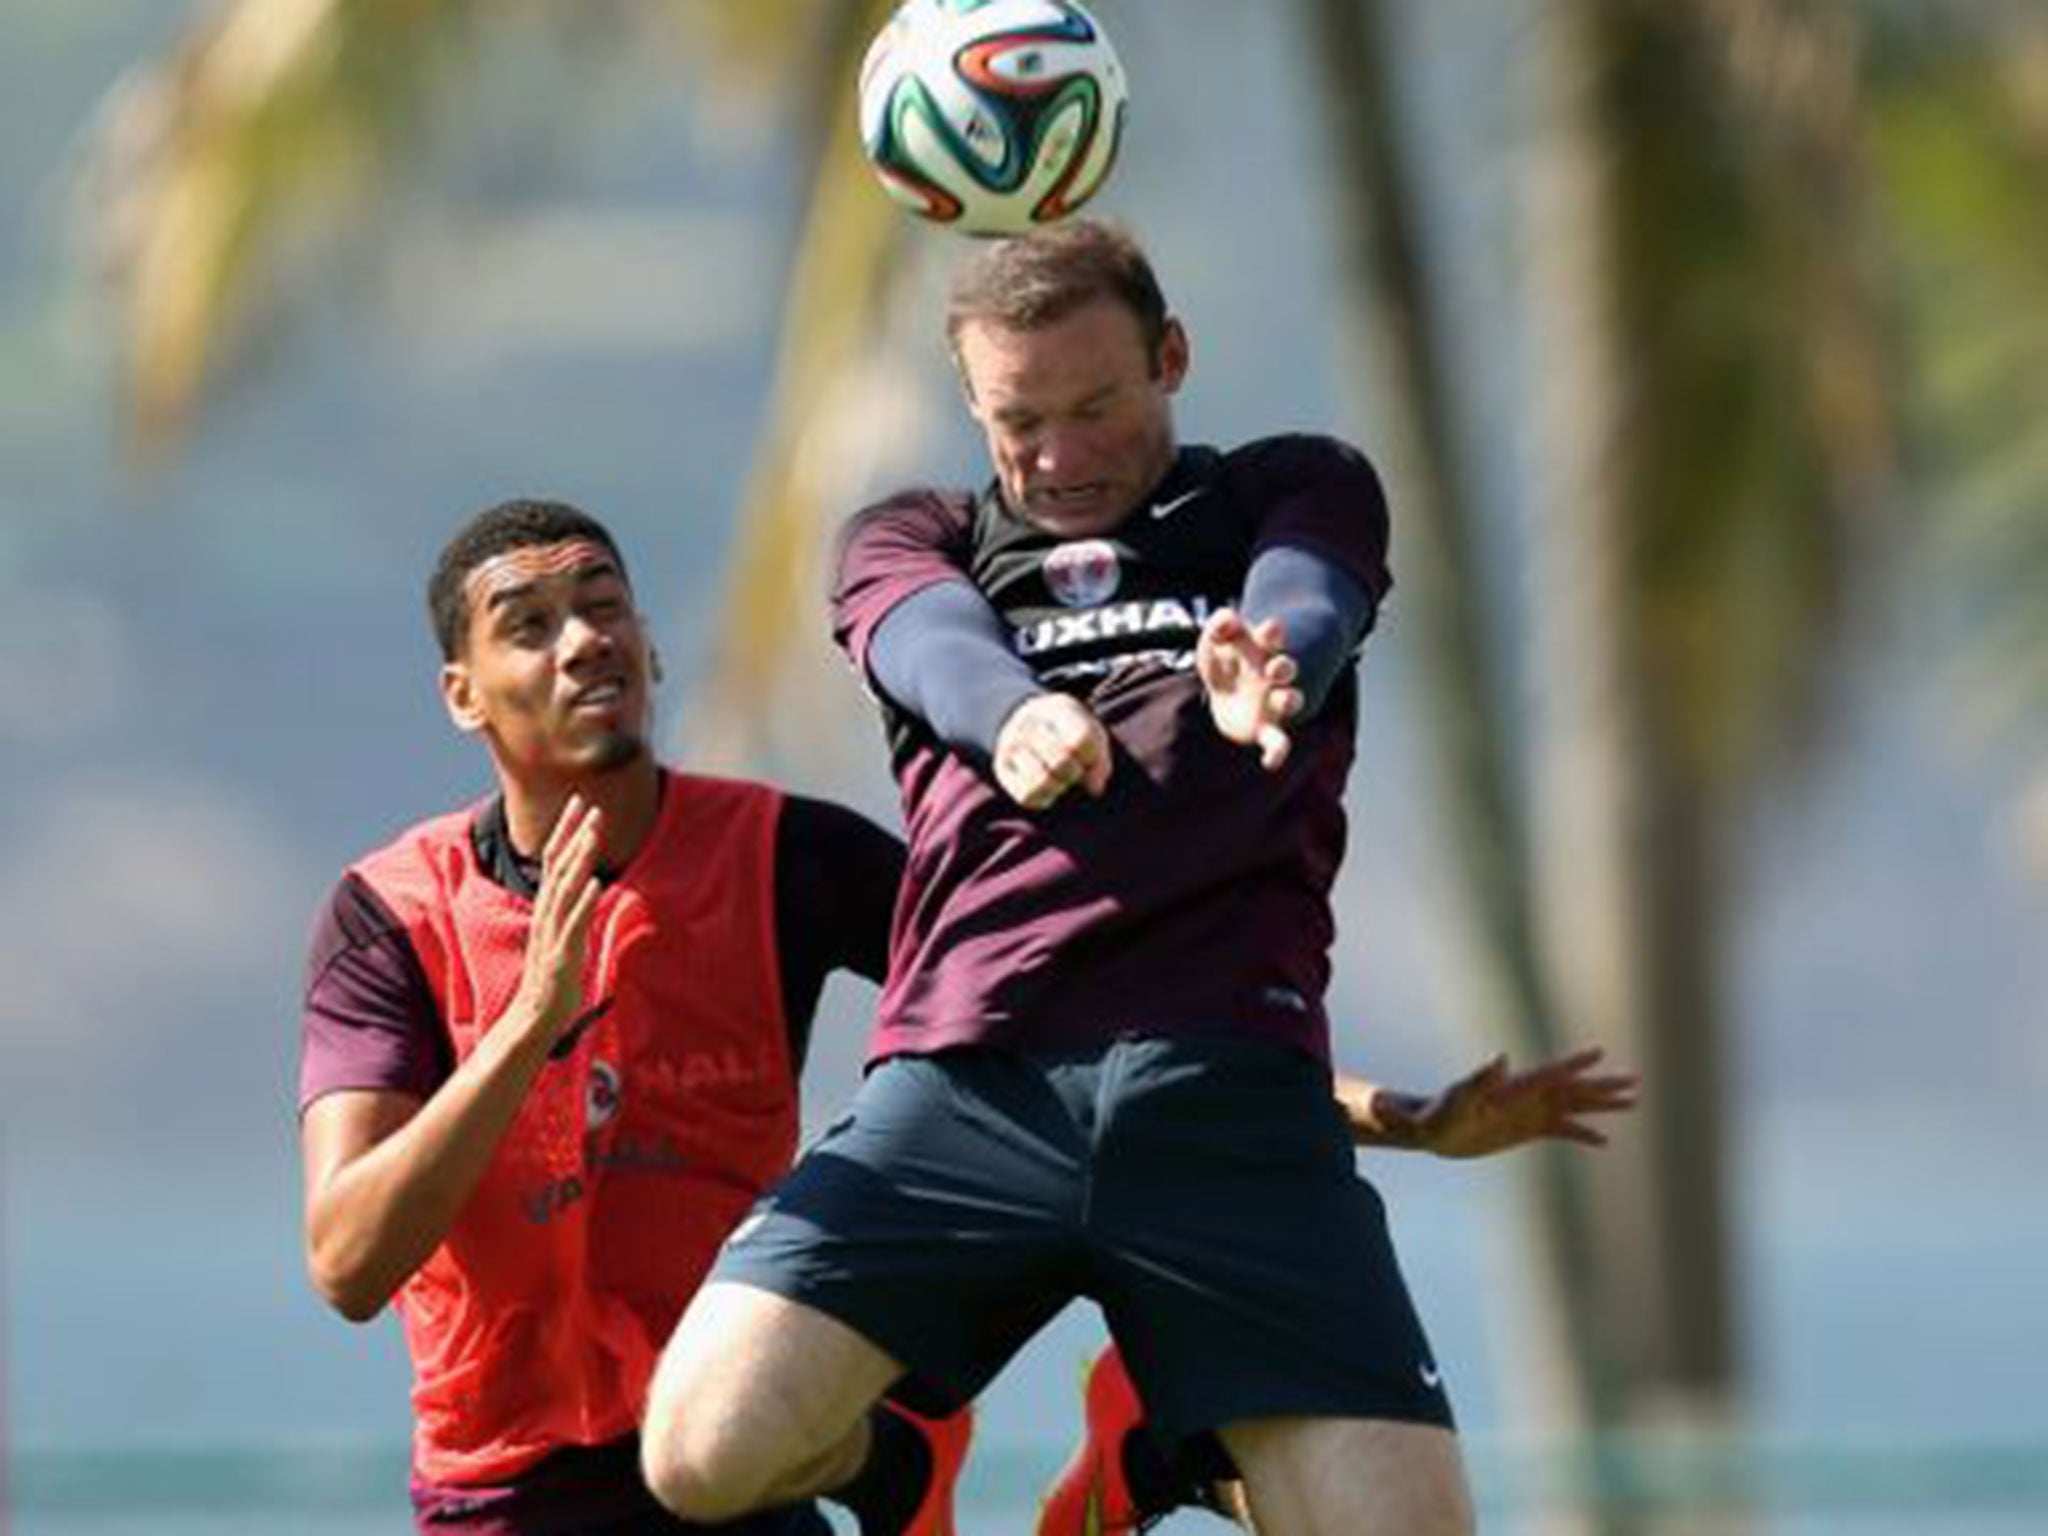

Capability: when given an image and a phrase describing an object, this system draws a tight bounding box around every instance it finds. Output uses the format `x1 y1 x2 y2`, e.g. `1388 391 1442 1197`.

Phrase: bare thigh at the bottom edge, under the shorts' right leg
1223 1419 1473 1536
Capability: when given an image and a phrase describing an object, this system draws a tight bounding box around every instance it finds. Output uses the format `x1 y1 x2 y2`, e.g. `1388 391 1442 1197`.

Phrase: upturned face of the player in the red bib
440 539 653 778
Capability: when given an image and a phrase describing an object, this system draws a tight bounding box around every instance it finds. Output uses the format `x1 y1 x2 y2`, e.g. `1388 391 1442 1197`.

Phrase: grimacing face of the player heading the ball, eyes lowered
954 299 1188 539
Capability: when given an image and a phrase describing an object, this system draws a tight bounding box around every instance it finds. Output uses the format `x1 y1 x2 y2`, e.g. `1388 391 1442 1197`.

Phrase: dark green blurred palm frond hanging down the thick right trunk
1608 0 1901 801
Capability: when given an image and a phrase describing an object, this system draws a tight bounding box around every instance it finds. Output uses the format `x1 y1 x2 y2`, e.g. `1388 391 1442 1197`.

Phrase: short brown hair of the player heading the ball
946 219 1167 358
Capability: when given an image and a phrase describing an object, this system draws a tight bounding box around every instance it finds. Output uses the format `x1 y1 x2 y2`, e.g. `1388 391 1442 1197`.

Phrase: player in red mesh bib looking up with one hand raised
299 502 969 1536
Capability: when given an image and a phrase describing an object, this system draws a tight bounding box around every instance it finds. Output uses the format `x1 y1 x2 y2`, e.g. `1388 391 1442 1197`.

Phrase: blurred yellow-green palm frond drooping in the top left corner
82 0 505 449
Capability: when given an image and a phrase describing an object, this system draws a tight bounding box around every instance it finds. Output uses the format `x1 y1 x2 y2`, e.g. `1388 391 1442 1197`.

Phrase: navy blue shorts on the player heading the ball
713 1036 1450 1460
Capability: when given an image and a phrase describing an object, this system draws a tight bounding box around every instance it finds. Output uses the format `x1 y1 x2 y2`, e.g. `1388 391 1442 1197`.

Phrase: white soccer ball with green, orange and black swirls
860 0 1128 233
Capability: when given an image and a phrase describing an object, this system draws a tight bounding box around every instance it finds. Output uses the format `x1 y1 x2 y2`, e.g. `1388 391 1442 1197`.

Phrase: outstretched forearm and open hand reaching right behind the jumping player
1337 1047 1640 1157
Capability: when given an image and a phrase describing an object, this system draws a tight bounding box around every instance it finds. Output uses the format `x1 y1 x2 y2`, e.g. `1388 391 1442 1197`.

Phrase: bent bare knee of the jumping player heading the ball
641 1282 903 1524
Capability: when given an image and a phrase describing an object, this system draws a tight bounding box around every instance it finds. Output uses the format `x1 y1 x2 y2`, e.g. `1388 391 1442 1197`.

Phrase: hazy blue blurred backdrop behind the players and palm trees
0 0 2048 1532
